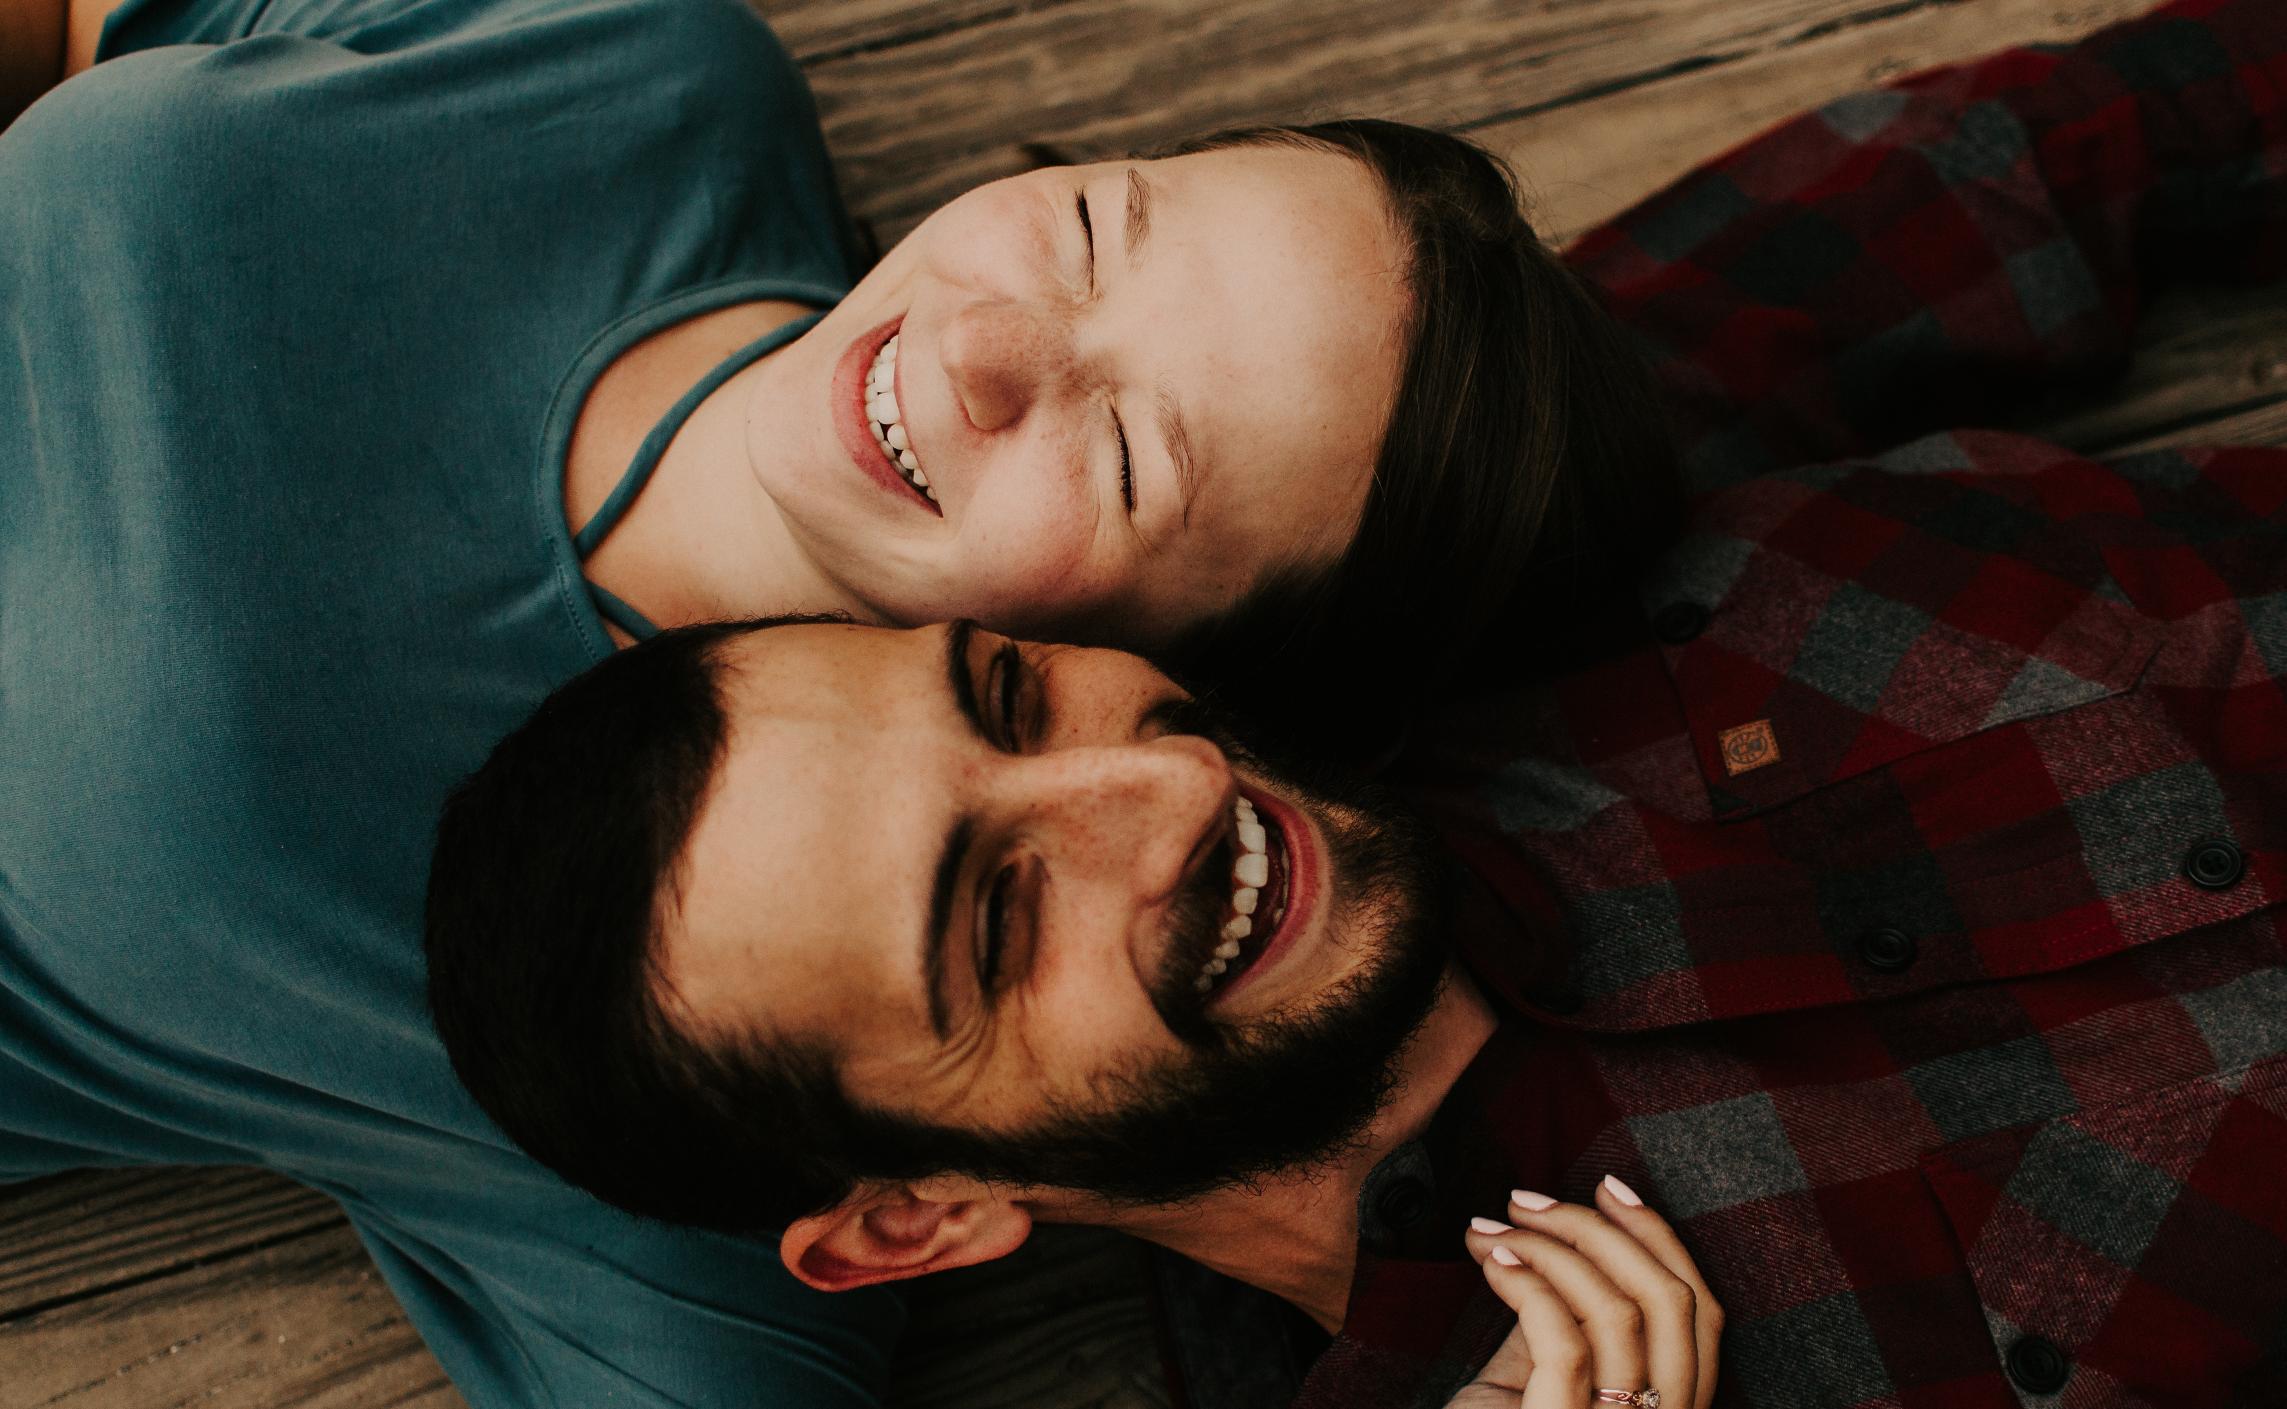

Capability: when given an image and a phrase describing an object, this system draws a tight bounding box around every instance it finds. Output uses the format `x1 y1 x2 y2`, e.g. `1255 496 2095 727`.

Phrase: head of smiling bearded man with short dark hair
430 620 1493 1324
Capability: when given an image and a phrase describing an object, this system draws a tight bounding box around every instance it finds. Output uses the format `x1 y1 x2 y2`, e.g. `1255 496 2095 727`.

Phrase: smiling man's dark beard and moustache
864 702 1448 1205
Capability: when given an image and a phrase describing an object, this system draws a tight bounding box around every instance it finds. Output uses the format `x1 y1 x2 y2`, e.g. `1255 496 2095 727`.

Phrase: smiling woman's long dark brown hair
1148 119 1683 750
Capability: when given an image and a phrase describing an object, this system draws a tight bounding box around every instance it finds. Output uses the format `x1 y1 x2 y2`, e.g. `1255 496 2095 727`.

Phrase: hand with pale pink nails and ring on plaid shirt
1448 1178 1722 1409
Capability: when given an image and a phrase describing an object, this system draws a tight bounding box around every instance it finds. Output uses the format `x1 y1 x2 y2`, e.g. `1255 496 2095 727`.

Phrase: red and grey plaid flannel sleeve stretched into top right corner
1571 0 2287 492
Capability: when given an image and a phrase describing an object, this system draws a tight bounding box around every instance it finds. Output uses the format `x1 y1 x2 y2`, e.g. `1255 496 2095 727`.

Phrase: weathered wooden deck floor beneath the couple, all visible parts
13 0 2287 1409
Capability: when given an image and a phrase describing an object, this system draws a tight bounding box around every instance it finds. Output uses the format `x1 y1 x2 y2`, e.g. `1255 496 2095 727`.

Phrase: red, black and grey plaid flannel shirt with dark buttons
1301 0 2287 1409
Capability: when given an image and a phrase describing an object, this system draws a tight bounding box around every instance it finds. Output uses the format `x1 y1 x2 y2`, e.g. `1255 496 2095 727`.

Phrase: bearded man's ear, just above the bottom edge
778 1180 1031 1292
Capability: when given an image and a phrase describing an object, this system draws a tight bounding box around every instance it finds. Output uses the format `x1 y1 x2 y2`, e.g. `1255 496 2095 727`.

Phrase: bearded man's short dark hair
425 618 851 1231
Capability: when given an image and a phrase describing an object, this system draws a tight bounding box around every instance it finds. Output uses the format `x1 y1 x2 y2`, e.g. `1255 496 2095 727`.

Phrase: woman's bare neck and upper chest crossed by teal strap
565 302 869 645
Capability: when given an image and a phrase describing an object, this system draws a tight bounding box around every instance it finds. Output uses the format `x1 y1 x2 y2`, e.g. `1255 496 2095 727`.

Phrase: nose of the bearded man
1011 734 1233 901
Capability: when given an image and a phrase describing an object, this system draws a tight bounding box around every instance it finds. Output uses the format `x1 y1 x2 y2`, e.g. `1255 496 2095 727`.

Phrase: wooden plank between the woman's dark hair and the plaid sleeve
1471 0 2150 242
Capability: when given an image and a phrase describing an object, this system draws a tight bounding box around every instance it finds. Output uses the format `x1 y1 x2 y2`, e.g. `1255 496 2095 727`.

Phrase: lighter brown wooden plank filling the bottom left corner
0 1226 464 1409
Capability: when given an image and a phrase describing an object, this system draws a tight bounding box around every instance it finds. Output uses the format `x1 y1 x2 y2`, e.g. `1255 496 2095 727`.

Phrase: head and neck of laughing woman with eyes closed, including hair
551 121 1676 737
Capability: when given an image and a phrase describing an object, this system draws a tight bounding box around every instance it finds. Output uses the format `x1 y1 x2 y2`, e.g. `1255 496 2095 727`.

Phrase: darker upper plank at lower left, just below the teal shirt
0 1169 341 1322
